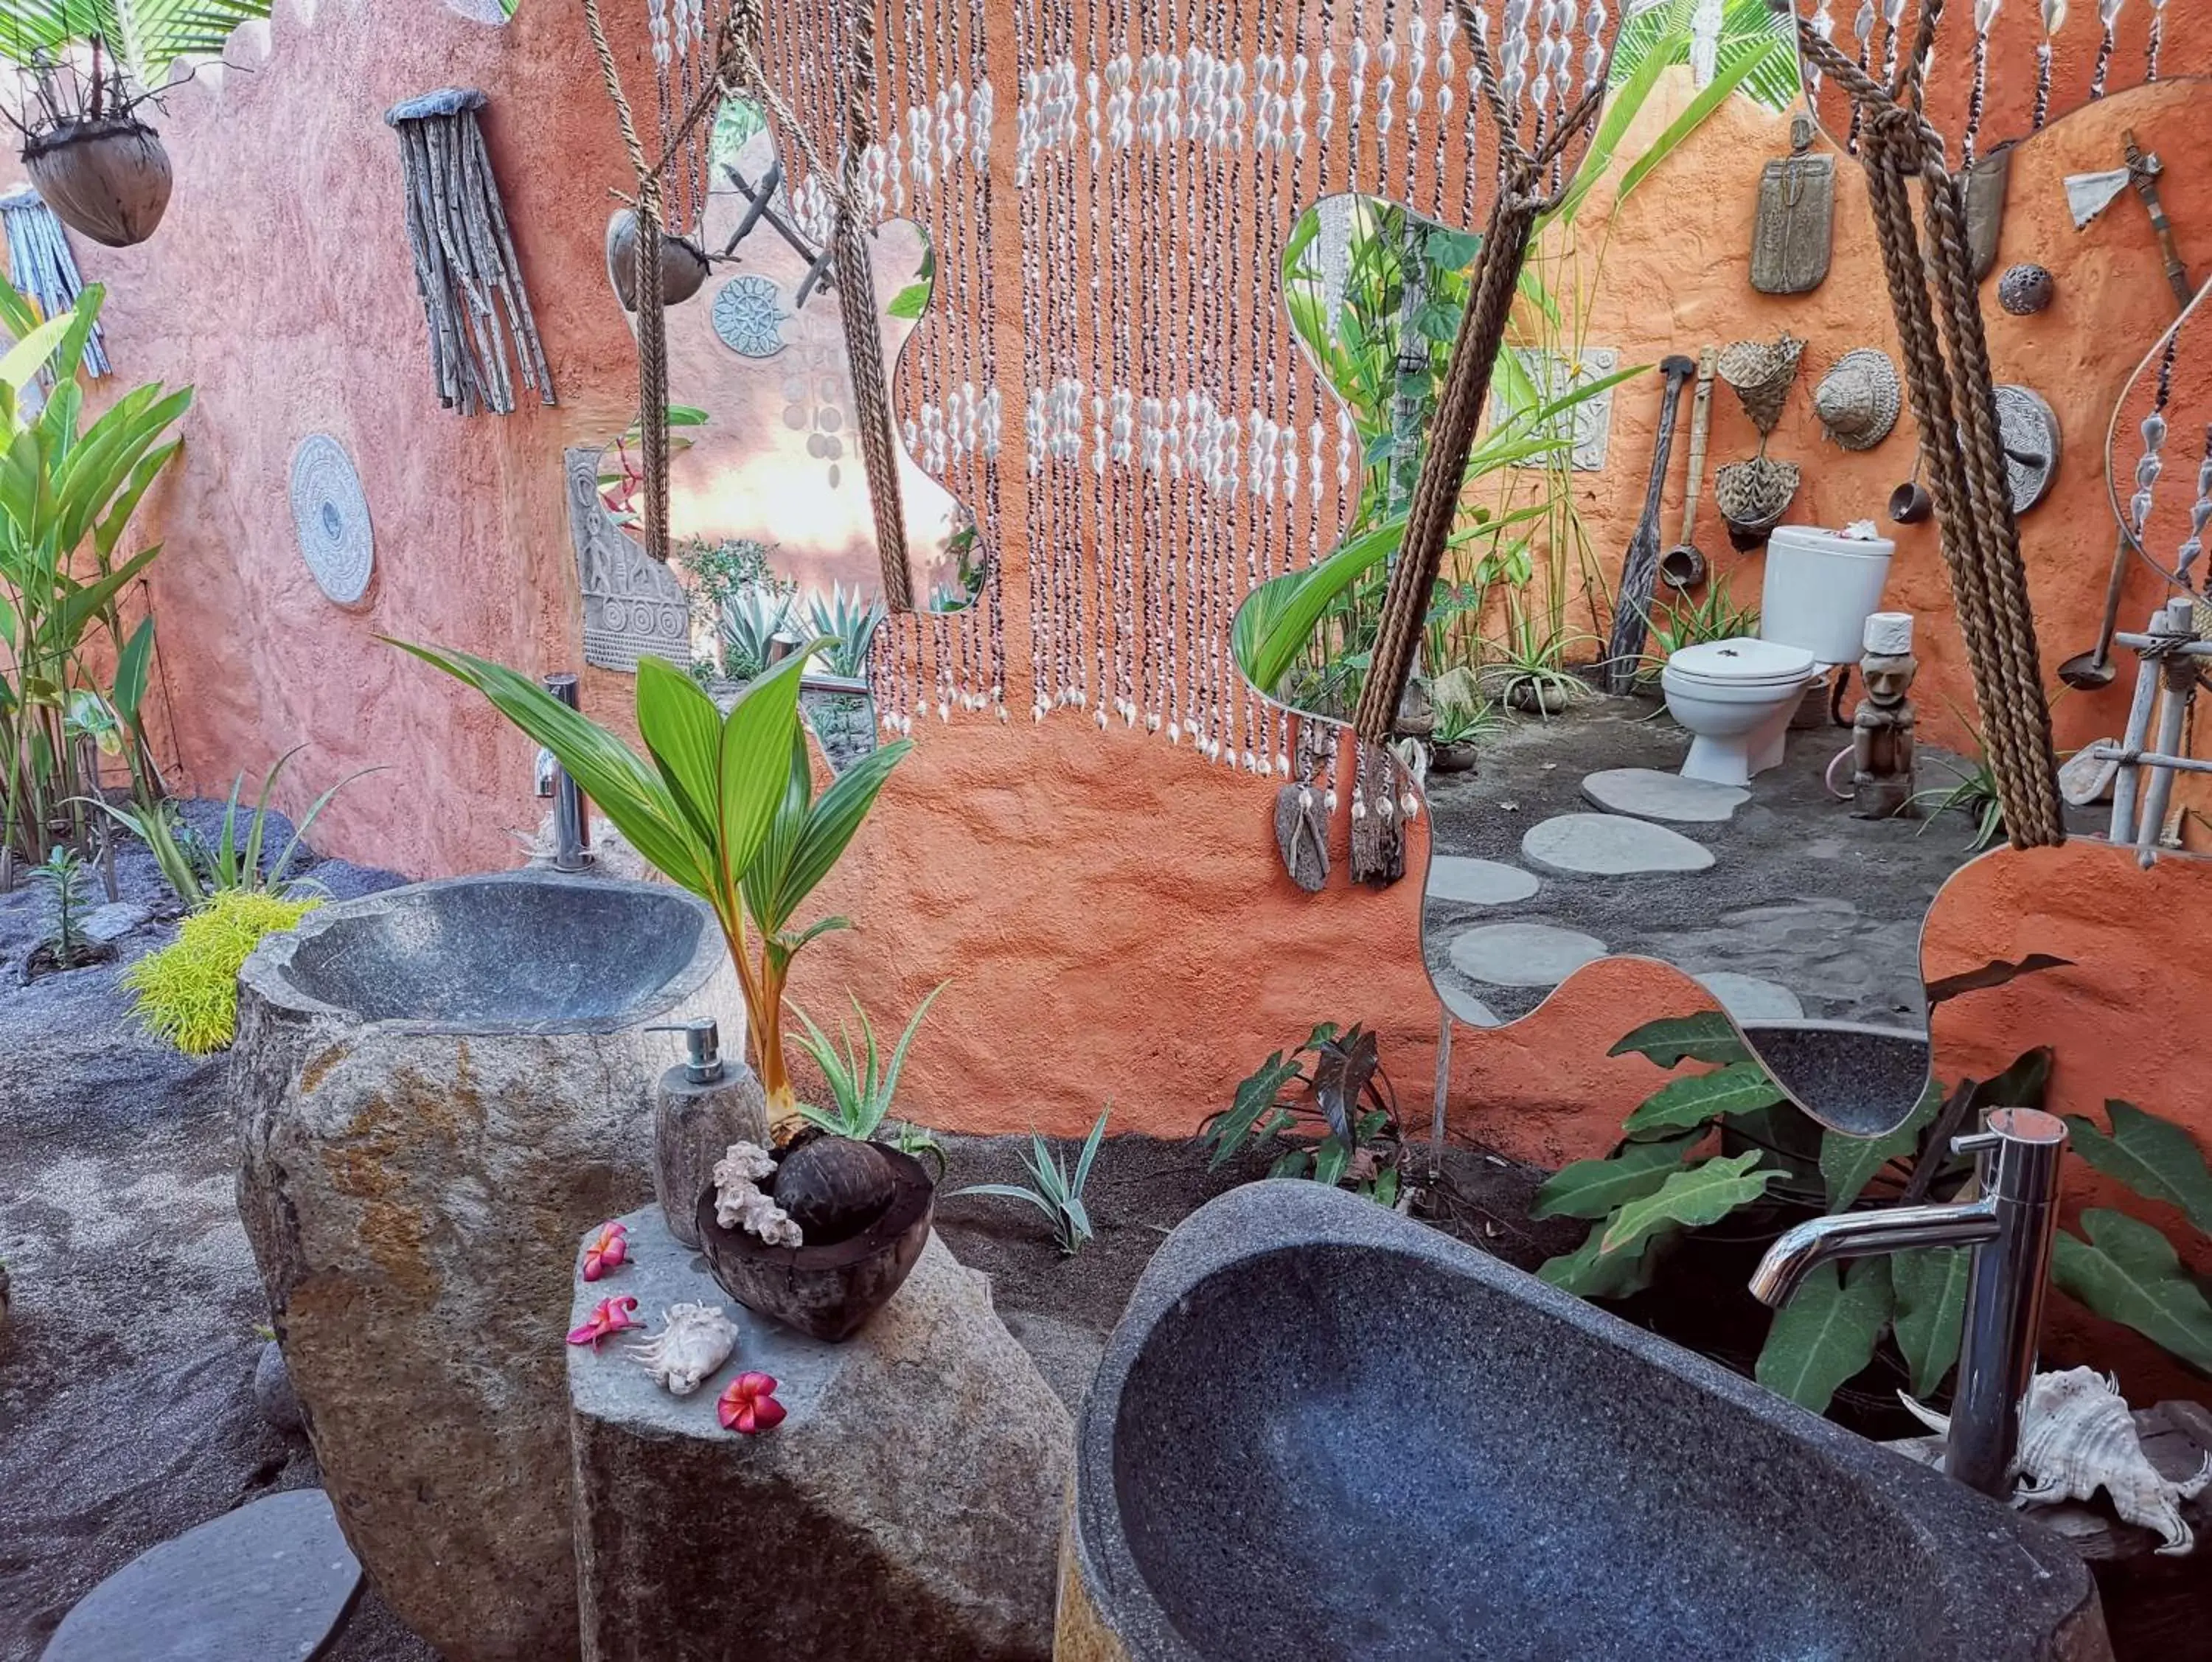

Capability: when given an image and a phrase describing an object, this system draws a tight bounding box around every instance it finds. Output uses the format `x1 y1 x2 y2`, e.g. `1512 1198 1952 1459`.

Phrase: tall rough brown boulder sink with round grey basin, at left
230 870 743 1662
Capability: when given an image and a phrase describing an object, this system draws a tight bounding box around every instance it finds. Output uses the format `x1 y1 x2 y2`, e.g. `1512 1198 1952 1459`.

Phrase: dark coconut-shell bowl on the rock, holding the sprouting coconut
699 1140 936 1343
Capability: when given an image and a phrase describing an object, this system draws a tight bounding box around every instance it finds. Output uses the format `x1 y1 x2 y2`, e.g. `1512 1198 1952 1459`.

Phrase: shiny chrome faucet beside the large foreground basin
1752 1109 2066 1501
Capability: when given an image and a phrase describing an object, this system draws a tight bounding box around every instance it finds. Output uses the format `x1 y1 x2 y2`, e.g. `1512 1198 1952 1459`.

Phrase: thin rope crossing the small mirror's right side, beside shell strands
830 0 914 611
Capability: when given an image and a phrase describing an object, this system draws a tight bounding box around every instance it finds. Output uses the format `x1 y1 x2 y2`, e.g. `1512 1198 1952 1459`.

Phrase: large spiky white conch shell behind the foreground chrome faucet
1898 1368 2212 1558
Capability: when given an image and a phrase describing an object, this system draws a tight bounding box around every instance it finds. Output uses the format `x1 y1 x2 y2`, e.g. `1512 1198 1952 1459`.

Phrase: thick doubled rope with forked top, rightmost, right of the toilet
1798 22 2066 848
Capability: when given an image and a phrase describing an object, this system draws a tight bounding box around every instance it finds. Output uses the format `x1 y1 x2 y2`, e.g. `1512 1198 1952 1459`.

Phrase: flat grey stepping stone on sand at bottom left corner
40 1489 361 1662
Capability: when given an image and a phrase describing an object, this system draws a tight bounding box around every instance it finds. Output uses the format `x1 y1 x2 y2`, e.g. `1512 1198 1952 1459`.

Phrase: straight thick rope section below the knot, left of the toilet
1354 181 1537 743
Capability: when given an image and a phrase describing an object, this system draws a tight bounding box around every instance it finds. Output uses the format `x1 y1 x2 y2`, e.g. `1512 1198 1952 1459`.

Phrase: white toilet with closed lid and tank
1659 524 1896 785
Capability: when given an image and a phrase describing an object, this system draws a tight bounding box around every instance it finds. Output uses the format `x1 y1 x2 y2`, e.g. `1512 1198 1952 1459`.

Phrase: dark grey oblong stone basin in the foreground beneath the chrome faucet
1055 1180 2110 1662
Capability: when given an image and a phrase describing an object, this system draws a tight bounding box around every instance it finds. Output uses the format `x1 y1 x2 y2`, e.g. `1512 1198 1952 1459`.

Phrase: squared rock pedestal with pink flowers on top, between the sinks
568 1206 1073 1662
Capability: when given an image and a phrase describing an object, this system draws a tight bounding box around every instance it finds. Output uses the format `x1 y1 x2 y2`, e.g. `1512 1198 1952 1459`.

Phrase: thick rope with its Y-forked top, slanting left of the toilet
1352 16 1604 743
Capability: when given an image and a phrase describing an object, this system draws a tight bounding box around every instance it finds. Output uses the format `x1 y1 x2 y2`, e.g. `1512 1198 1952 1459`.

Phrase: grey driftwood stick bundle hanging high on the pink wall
385 86 553 416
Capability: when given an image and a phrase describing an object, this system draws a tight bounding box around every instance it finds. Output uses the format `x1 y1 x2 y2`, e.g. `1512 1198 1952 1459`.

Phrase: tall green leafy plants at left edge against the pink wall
0 283 192 861
